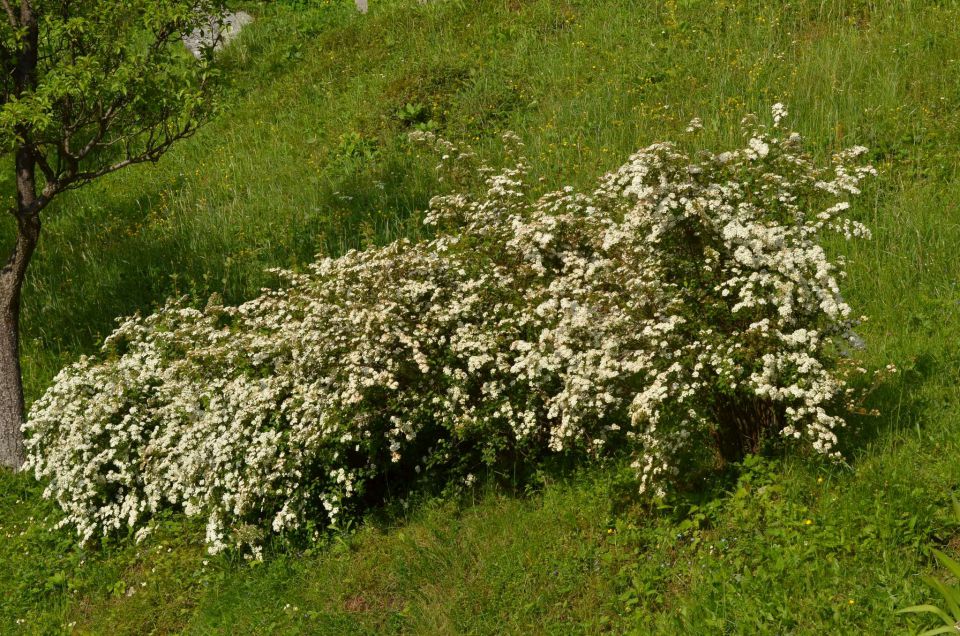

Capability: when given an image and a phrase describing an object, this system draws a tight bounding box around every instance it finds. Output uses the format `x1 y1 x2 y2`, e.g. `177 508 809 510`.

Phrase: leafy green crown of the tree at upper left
0 0 221 164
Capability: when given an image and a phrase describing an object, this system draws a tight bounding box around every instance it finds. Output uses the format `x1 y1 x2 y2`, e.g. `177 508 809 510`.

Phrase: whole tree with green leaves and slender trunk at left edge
0 0 223 470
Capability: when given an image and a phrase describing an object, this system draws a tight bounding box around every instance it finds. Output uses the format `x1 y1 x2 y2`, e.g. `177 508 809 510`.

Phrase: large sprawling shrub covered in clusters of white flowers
25 104 873 554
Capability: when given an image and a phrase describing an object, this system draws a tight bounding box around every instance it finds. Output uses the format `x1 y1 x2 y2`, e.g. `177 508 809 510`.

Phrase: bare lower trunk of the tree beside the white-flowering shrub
0 217 40 470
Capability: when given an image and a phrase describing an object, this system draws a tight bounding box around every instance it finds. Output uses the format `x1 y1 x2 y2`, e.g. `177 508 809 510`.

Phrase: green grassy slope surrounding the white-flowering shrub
0 0 960 634
